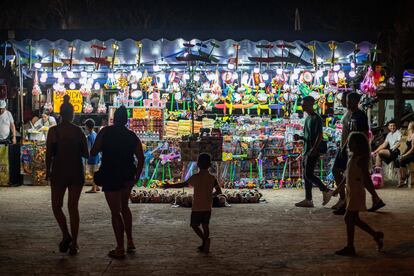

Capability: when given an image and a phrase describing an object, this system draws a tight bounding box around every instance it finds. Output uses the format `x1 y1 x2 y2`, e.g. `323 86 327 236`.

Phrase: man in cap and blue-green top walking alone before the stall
295 96 333 207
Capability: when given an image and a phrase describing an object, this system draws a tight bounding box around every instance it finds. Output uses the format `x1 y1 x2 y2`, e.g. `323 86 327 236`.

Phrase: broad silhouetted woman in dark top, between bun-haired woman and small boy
91 106 144 258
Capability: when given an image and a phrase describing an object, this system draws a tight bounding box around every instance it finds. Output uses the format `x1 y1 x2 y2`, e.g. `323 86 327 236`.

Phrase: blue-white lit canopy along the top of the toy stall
9 39 373 75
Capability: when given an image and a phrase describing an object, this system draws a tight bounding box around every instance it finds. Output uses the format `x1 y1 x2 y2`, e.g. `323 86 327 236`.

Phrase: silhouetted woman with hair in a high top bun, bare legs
46 95 89 255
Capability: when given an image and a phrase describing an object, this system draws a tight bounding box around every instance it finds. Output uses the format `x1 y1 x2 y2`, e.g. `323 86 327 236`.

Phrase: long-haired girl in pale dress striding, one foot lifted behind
335 132 384 256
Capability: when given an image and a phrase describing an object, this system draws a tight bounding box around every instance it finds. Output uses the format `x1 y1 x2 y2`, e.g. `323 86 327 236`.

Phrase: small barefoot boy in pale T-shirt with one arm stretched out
164 153 221 253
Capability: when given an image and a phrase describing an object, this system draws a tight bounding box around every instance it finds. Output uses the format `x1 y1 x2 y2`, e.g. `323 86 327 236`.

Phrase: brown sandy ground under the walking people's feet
0 186 414 275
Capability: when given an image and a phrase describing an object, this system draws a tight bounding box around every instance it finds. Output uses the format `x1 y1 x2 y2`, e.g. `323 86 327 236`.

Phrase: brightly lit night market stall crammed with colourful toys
0 33 384 189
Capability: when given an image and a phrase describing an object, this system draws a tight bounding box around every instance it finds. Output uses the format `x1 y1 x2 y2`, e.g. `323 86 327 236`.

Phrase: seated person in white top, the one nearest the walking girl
372 120 401 168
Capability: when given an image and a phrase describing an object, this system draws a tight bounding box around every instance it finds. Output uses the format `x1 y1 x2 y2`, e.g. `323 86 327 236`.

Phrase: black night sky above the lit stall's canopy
0 0 414 31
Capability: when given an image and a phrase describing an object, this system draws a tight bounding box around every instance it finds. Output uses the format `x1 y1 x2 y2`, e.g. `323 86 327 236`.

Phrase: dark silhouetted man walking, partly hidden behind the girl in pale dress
332 92 385 215
